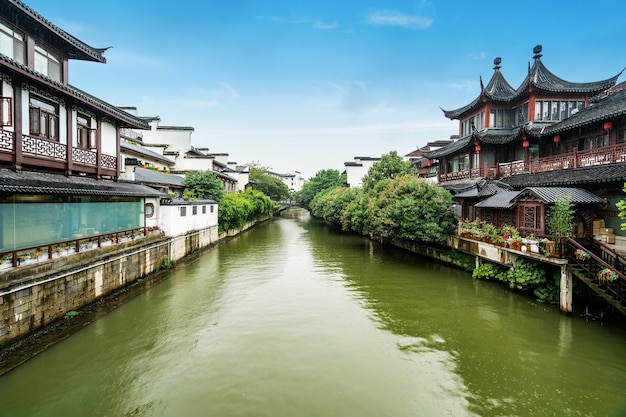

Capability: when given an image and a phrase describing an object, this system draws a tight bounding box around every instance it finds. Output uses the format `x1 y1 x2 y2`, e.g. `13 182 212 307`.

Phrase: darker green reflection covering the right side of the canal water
298 211 626 416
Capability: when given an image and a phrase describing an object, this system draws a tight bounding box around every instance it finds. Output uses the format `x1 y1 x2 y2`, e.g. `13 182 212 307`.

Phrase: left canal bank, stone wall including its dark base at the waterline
0 218 268 375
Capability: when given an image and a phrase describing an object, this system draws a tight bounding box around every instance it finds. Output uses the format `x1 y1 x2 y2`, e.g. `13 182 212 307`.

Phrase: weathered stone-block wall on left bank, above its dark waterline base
0 222 227 348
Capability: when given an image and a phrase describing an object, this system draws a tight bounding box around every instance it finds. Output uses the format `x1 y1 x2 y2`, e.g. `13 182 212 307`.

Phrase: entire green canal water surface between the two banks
0 209 626 417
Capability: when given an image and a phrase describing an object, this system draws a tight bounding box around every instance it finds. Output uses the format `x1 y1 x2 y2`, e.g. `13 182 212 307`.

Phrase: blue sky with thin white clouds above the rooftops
25 0 626 178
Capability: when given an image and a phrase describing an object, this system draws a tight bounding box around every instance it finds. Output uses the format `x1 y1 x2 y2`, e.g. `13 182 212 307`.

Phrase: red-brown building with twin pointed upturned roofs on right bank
422 46 626 235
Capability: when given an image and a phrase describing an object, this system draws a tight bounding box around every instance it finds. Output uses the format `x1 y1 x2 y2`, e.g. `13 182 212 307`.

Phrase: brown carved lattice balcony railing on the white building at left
0 130 117 177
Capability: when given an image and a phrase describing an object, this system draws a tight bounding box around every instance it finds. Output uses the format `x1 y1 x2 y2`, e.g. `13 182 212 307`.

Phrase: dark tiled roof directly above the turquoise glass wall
0 169 163 197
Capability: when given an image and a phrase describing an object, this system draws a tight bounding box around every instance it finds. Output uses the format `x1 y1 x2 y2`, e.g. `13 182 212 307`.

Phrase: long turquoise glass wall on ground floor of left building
0 194 144 251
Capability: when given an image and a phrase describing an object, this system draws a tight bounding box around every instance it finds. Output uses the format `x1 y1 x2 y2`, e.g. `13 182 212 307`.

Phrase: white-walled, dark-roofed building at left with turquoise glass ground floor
0 0 161 252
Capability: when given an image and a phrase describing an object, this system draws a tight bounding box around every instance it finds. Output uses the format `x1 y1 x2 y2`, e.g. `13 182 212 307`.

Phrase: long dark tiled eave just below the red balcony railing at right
501 164 626 190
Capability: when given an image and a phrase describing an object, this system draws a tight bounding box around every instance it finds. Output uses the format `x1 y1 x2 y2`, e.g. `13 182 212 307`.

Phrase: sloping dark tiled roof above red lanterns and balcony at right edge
541 90 626 136
